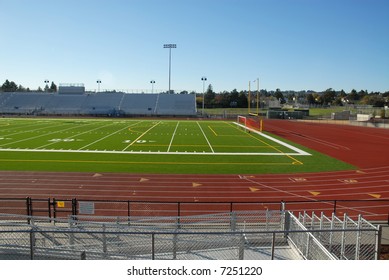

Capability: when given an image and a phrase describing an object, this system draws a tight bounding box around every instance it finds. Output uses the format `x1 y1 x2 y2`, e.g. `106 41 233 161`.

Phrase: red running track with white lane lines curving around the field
0 120 389 221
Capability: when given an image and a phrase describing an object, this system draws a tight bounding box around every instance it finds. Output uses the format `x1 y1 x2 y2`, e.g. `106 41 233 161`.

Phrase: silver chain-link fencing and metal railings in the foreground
0 211 380 260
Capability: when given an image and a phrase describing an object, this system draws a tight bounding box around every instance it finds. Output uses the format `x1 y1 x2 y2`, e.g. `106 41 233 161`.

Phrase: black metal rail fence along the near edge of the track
0 197 389 224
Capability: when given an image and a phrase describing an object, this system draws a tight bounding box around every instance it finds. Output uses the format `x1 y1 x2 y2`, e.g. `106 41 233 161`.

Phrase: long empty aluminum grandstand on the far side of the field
0 92 197 116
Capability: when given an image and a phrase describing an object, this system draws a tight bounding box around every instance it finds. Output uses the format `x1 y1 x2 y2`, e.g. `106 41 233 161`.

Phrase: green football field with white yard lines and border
0 118 354 174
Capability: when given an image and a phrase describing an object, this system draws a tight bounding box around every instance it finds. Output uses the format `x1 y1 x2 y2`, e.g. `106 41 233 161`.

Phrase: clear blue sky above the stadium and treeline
0 0 389 92
